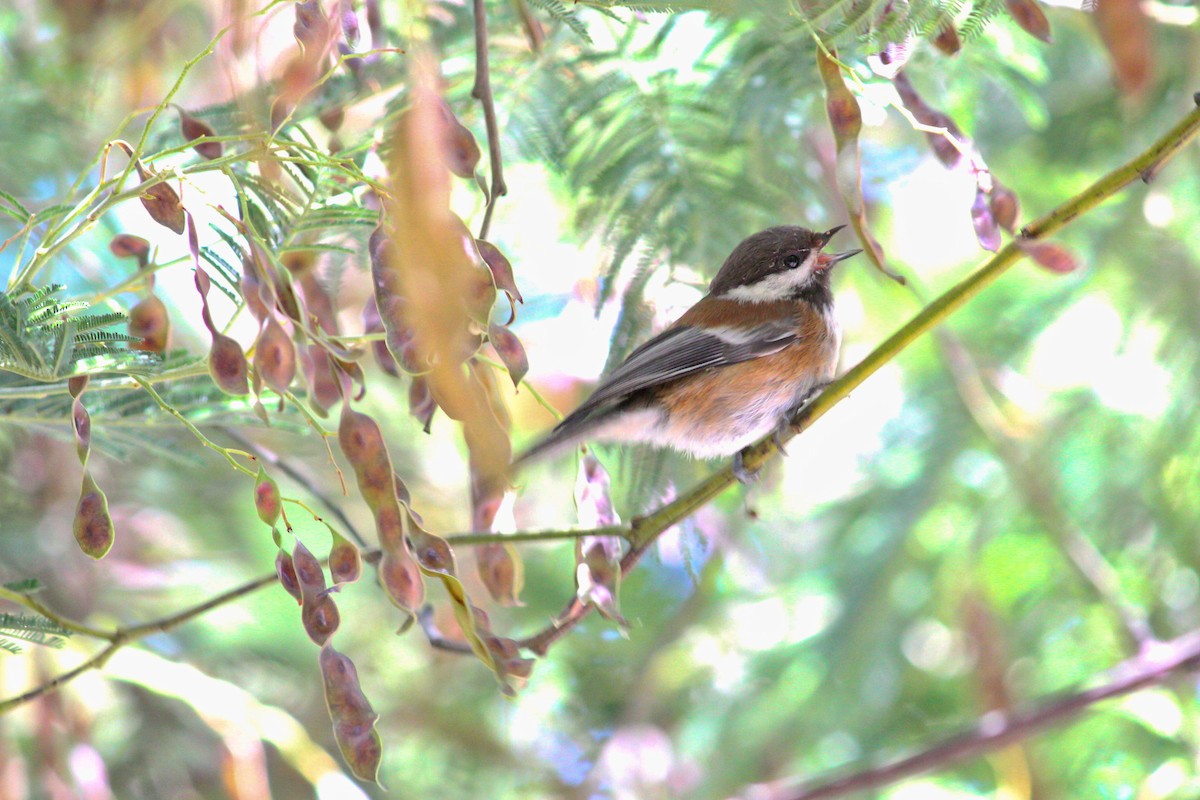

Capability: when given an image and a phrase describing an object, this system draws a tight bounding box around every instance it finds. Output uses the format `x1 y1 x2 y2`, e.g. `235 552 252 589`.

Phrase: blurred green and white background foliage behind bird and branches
0 0 1200 799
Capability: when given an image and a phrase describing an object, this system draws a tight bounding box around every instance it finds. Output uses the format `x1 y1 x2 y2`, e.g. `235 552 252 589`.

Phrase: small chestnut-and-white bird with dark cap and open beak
514 225 863 483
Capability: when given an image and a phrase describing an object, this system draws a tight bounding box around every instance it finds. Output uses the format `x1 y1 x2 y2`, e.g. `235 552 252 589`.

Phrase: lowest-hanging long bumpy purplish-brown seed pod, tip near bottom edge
319 644 383 781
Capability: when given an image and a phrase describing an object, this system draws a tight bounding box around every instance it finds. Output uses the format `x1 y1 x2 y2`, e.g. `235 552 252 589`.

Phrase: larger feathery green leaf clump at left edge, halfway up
0 284 157 383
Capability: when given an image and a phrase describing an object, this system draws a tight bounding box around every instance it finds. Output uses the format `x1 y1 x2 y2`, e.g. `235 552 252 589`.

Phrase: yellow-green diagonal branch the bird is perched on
520 92 1200 655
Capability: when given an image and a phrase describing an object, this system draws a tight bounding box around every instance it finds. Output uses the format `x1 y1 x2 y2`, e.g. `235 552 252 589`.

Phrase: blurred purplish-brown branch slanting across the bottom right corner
755 631 1200 800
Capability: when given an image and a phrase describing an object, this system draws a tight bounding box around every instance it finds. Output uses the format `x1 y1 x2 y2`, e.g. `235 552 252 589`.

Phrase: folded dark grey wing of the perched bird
563 320 798 423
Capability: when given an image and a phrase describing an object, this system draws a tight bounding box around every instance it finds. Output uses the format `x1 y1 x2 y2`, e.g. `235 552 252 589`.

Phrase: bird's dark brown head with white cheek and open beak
709 225 863 305
